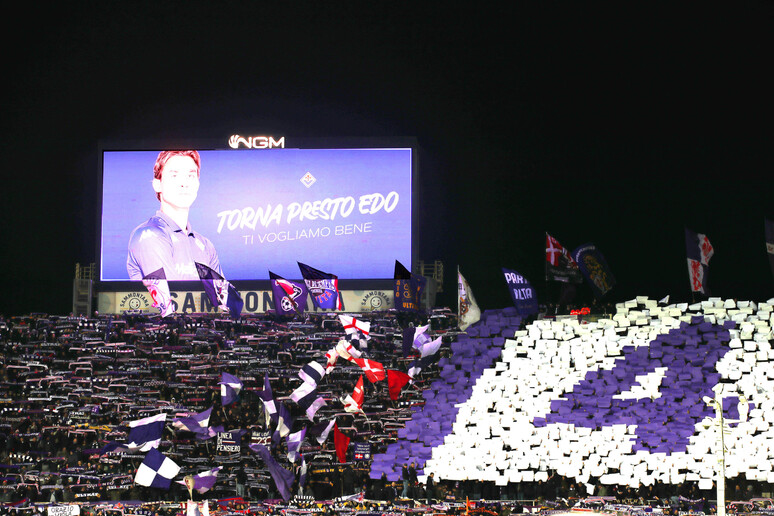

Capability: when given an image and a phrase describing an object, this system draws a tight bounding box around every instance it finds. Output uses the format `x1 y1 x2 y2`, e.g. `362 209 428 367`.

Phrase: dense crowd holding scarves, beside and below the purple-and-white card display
0 309 772 514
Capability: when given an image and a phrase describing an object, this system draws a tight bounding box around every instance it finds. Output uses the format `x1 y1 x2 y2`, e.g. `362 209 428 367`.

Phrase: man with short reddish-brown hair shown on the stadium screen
126 150 223 281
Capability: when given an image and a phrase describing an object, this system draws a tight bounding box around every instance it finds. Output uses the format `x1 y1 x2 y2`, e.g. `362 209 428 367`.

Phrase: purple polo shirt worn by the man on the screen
126 211 223 281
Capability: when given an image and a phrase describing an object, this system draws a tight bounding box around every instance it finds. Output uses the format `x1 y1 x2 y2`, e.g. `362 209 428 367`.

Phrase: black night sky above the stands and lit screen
0 1 774 315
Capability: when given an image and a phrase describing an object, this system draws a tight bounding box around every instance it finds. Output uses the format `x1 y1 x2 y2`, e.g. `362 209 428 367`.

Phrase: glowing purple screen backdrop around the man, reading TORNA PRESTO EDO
99 144 413 282
